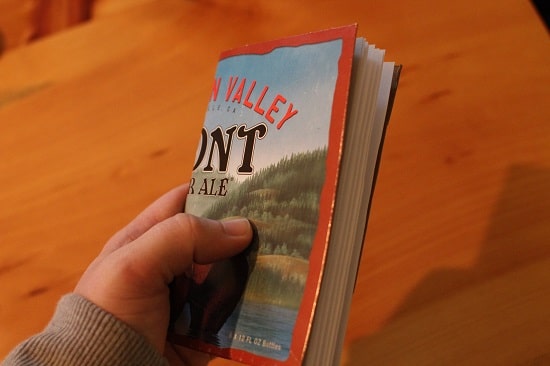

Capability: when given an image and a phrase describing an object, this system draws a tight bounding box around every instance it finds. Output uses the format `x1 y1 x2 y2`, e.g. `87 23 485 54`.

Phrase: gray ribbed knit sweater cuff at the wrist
2 294 168 366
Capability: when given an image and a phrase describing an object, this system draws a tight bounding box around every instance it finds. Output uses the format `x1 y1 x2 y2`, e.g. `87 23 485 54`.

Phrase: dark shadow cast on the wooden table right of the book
345 166 550 366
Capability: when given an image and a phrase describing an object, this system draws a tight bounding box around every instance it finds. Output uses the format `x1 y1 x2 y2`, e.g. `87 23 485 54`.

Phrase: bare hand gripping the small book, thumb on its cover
75 184 252 365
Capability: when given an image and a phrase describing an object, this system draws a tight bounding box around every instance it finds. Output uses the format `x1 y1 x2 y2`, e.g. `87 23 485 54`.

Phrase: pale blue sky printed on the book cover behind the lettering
201 40 342 178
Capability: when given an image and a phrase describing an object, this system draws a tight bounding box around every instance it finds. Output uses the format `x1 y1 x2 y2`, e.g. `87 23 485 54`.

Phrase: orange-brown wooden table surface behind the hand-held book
0 0 550 365
